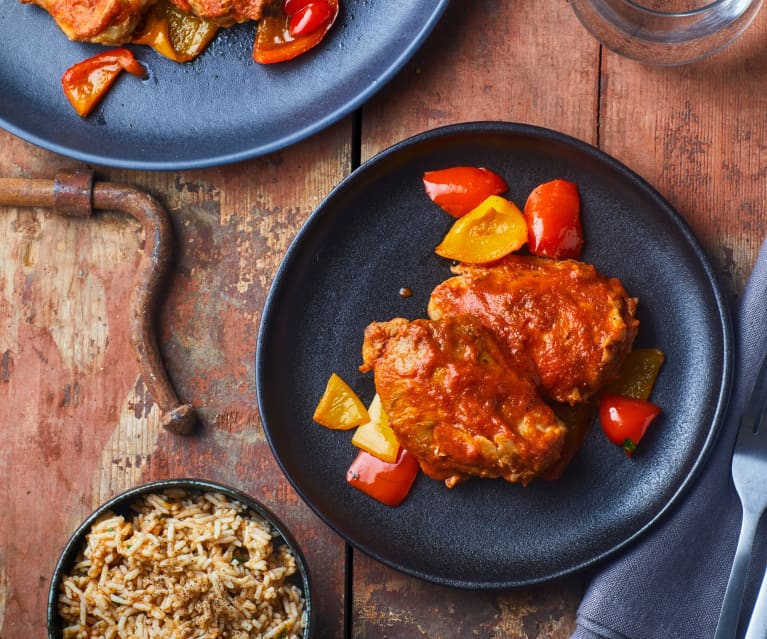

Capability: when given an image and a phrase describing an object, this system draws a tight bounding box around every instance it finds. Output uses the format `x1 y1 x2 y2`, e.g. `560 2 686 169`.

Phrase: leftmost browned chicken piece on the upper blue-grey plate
21 0 156 45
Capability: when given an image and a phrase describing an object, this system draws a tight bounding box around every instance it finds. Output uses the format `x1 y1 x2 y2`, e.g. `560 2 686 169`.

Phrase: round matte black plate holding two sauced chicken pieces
256 123 732 588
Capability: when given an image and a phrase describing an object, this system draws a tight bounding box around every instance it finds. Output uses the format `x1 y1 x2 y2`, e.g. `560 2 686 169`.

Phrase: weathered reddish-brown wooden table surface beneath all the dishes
0 0 767 639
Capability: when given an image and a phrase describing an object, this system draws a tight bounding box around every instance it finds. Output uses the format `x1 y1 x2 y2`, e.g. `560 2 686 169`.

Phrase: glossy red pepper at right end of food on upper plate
253 0 339 64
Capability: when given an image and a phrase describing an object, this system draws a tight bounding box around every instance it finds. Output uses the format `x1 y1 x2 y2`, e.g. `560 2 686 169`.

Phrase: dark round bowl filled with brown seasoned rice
48 479 312 639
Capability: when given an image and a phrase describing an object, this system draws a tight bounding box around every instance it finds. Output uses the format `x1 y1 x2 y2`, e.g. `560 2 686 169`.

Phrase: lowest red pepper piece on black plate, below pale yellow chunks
346 448 419 506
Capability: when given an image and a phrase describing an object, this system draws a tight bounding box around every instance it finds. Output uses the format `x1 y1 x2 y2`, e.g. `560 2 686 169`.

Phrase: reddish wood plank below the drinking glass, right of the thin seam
600 12 767 294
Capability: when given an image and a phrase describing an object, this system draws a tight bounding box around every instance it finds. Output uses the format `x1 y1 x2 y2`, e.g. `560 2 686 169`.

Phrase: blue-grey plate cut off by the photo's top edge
0 0 448 170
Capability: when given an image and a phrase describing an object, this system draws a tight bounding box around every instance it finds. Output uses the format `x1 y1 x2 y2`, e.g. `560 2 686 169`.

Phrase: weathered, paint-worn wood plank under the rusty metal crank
0 122 351 637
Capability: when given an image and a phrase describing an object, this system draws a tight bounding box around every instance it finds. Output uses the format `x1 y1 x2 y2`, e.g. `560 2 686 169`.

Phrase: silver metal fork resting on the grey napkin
714 357 767 639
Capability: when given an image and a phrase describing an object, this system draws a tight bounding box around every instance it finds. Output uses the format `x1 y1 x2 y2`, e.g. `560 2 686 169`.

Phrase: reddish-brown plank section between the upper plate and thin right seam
362 0 599 160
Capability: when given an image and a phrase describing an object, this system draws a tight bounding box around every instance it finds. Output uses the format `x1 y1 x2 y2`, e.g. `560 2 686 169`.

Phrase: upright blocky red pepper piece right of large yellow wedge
524 180 583 259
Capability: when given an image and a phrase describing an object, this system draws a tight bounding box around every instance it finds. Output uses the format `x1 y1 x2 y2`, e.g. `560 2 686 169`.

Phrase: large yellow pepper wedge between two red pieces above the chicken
435 195 527 264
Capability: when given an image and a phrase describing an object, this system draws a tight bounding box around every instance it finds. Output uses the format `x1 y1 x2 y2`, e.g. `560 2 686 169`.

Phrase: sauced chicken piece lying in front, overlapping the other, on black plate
360 316 566 487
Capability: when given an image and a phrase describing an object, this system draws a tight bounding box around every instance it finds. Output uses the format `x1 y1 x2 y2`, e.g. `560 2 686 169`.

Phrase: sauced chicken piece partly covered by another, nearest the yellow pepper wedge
428 255 639 404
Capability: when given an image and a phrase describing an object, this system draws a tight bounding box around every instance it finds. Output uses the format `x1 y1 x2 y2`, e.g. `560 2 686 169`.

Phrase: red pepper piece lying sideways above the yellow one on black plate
423 166 509 217
